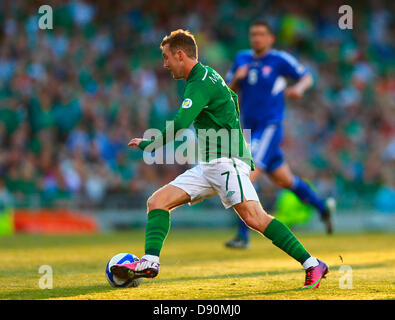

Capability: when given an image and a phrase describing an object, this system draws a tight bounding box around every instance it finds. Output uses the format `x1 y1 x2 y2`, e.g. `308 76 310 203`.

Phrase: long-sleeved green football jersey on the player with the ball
139 62 254 170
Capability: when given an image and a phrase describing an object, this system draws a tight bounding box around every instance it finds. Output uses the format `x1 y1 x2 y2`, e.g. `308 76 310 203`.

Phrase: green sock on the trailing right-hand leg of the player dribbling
263 219 311 264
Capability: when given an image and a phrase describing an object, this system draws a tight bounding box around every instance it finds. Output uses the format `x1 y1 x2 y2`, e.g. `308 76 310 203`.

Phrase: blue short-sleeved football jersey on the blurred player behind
225 49 308 130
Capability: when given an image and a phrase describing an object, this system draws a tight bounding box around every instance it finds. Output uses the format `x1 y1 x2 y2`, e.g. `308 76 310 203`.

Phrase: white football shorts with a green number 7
169 158 259 209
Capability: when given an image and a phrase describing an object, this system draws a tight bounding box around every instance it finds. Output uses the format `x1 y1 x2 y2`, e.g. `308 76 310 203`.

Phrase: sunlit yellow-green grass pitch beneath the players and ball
0 229 395 300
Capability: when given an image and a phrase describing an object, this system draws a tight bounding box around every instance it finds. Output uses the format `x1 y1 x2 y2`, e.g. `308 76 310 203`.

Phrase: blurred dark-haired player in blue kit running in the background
225 21 336 248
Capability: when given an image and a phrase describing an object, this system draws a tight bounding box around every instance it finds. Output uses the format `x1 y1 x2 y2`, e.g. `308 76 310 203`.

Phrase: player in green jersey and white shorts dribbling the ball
111 29 328 288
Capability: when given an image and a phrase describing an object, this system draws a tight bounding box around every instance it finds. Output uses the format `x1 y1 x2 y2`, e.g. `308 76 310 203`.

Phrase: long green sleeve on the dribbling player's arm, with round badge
139 81 210 152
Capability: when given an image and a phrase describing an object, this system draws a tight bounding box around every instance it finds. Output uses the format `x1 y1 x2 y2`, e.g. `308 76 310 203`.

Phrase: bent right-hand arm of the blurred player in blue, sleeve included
281 52 314 99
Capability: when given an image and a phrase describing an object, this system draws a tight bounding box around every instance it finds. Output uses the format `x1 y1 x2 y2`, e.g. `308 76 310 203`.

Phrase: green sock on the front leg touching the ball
145 209 170 257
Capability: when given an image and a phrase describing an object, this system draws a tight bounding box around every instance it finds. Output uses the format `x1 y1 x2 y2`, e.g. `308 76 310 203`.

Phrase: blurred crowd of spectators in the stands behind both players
0 0 395 212
